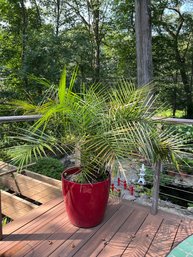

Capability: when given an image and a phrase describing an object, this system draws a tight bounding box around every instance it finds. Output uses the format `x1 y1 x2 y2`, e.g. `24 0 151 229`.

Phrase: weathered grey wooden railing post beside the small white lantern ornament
151 161 162 215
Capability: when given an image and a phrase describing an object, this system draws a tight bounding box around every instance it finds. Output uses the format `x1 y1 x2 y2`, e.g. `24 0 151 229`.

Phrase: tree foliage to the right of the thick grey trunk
152 1 193 118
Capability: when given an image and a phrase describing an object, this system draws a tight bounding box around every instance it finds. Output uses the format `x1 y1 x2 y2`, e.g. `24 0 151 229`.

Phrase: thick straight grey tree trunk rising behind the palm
135 0 153 87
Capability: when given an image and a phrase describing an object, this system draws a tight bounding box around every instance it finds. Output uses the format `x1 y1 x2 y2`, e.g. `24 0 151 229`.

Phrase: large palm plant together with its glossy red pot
8 69 191 227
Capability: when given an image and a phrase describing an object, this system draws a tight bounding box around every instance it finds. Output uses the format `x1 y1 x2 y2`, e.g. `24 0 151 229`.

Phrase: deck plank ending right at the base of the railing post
122 214 163 257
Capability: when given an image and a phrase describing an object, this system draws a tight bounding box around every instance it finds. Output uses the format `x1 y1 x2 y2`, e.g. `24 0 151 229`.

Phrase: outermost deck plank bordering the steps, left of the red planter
0 202 66 256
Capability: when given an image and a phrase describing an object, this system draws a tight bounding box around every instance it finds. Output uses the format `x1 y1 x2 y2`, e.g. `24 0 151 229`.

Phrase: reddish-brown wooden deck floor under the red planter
0 198 193 254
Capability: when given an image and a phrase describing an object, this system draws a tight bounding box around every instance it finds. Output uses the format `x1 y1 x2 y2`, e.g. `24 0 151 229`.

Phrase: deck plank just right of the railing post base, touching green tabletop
145 219 180 257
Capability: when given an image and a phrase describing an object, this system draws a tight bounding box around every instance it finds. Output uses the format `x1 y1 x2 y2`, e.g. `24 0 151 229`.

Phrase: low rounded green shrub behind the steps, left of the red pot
30 157 64 180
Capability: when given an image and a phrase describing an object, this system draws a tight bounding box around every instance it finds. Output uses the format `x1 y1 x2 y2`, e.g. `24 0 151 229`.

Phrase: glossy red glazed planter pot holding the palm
62 167 110 228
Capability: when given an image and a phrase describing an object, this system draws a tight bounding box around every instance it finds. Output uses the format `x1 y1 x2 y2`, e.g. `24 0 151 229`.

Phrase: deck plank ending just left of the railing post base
97 208 148 257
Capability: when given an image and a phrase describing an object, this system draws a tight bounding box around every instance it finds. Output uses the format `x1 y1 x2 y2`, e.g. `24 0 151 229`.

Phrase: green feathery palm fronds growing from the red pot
8 69 191 182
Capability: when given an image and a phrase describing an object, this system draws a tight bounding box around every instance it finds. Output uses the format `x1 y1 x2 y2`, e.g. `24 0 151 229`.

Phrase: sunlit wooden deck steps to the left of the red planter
0 162 61 220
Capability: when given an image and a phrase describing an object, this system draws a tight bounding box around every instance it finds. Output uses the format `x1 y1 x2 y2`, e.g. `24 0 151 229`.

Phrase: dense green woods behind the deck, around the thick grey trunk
0 0 193 118
